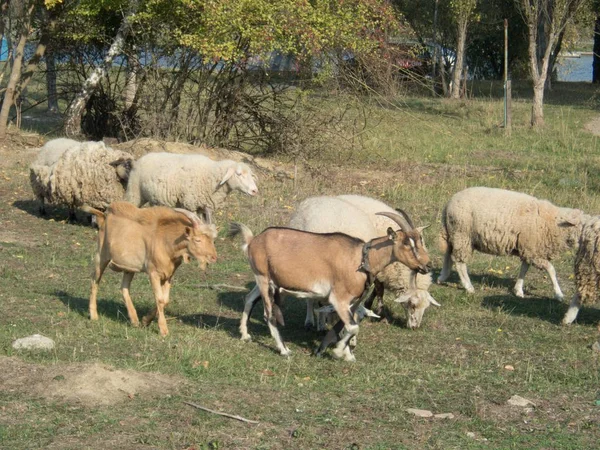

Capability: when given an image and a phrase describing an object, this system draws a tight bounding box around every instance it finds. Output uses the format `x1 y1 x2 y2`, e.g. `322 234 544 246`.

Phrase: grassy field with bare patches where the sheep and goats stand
0 84 600 449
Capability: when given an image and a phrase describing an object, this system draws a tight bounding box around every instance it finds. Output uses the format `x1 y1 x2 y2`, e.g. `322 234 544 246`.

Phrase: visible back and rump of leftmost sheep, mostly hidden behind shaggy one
29 138 79 215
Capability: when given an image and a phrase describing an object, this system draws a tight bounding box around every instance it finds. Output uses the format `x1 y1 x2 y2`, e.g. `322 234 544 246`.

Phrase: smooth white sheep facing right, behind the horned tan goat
125 152 258 222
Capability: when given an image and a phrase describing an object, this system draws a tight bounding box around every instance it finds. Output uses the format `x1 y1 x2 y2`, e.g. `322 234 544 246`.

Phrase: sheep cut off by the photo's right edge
562 216 600 325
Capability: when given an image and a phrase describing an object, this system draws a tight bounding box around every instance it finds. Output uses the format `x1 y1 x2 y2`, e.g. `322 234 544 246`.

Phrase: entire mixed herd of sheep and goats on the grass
30 139 600 361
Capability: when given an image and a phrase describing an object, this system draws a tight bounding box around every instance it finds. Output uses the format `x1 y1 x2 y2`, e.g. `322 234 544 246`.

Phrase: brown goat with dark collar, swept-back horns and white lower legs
230 213 430 361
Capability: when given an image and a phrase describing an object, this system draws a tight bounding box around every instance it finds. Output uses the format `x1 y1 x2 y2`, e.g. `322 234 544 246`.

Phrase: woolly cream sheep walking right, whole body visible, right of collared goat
438 187 587 299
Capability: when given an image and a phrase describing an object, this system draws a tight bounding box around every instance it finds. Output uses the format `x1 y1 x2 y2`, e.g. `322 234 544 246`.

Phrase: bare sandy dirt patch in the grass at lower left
0 357 185 407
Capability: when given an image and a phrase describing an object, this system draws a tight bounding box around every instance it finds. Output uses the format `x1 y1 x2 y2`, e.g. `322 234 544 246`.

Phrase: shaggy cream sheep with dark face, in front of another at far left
34 142 133 219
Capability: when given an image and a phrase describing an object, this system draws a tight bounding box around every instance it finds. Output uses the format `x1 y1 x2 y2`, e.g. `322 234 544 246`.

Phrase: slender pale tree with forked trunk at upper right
515 0 586 127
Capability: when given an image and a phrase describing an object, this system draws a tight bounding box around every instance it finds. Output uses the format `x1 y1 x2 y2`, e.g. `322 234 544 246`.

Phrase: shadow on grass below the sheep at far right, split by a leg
481 295 600 325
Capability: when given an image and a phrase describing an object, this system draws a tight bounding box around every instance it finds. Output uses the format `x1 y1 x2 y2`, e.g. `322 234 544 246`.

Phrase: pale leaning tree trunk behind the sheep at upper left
64 0 138 137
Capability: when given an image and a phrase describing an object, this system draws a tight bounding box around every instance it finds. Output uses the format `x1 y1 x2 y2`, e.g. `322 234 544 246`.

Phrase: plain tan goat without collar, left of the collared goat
82 202 217 336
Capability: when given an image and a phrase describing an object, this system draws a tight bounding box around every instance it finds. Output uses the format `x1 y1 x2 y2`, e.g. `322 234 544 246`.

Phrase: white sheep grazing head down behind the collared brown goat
289 195 439 328
